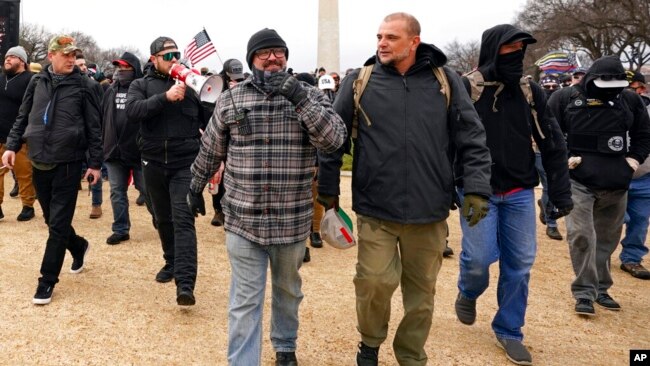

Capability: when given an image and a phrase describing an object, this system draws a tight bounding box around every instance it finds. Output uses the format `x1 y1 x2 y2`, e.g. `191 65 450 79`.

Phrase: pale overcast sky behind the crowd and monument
21 0 526 72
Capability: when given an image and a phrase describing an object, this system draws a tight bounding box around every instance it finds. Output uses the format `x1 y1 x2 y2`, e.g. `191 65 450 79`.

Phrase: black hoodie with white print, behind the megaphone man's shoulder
102 52 143 164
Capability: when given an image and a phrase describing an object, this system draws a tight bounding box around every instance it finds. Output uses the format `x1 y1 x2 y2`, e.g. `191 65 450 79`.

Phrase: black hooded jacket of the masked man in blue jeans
459 24 573 208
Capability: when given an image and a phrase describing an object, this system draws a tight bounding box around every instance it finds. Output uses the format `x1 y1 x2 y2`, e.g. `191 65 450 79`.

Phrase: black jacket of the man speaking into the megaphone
126 68 209 169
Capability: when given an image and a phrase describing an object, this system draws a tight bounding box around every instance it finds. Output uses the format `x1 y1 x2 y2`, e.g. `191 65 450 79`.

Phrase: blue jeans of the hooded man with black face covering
458 189 537 341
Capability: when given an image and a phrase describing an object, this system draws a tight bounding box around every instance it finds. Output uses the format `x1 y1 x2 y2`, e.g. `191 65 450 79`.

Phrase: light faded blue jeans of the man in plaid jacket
226 231 305 366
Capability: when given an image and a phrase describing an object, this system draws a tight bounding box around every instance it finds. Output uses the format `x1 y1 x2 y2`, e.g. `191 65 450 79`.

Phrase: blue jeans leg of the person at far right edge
620 174 650 263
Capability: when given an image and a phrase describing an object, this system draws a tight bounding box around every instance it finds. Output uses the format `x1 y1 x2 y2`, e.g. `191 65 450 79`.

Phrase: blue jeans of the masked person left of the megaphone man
104 160 146 235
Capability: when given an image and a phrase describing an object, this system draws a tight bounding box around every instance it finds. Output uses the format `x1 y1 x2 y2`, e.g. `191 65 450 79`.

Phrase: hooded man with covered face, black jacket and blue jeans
455 24 573 365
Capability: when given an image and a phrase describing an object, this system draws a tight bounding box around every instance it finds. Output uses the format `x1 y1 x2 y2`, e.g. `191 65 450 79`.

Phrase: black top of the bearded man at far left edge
0 71 34 144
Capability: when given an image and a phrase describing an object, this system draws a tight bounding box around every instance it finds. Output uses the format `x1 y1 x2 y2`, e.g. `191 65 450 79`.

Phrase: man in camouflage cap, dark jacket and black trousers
2 35 102 305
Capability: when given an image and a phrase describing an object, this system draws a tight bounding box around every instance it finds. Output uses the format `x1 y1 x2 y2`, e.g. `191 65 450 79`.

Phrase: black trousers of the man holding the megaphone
143 161 197 290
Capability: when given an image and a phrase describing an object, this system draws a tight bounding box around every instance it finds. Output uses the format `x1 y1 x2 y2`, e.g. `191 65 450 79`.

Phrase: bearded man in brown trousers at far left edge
0 46 36 221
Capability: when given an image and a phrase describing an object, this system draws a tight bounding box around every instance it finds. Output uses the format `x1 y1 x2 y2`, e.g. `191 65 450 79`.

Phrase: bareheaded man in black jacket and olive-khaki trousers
318 13 490 365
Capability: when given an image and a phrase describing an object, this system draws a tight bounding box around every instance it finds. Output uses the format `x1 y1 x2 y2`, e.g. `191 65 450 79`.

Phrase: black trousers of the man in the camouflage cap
32 161 84 286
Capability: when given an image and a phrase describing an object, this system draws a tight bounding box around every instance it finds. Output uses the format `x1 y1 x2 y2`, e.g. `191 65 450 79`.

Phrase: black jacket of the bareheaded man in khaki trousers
318 43 490 224
